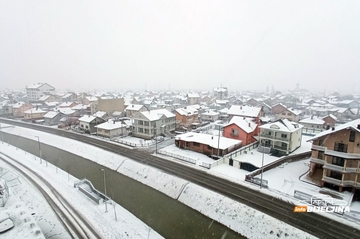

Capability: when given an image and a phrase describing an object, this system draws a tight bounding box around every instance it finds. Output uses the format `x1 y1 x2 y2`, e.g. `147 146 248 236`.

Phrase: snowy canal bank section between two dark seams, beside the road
118 160 187 199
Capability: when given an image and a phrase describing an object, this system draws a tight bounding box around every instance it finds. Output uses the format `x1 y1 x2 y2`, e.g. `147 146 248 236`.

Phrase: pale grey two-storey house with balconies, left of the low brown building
132 109 175 139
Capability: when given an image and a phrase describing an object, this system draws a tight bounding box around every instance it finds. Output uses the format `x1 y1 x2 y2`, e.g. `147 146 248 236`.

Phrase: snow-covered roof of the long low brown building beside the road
175 132 241 149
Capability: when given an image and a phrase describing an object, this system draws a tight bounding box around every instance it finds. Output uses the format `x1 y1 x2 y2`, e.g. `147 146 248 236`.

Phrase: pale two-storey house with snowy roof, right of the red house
259 119 303 155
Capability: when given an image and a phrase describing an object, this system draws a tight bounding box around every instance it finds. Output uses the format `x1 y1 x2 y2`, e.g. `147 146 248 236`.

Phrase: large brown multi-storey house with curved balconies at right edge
308 119 360 193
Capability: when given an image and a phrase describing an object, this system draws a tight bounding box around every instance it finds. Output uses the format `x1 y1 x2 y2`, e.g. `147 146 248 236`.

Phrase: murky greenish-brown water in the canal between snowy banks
3 133 245 239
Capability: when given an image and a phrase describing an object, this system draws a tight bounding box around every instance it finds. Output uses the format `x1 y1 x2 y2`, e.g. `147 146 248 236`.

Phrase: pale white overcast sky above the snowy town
0 0 360 92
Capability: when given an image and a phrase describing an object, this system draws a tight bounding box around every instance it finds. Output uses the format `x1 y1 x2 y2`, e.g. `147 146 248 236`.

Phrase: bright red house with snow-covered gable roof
223 116 259 146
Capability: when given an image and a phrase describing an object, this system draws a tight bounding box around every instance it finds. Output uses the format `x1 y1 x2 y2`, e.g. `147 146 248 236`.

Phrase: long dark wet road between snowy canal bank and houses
0 119 360 239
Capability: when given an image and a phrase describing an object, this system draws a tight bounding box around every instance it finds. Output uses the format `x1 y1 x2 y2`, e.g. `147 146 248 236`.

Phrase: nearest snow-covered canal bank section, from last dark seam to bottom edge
179 184 316 239
